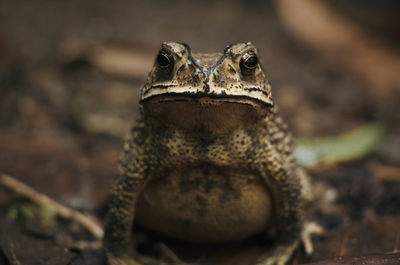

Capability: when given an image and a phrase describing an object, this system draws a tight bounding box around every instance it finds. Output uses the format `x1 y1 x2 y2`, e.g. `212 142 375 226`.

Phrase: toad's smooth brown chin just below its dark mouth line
142 97 270 133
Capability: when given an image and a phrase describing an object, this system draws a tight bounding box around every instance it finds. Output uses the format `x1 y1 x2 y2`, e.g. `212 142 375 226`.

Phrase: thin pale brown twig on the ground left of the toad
0 174 104 239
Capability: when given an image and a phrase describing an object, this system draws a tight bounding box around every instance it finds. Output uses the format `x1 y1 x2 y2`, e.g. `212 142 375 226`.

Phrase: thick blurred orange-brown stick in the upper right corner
275 0 400 98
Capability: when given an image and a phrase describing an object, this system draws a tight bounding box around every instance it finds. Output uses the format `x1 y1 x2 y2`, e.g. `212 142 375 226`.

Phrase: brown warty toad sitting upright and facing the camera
104 43 311 265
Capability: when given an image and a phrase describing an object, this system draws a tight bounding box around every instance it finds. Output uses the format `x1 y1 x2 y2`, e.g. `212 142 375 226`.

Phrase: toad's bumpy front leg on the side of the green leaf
253 148 310 265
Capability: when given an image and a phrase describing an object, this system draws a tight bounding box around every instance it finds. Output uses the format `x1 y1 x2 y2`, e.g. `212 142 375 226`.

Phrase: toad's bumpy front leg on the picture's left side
104 141 149 265
